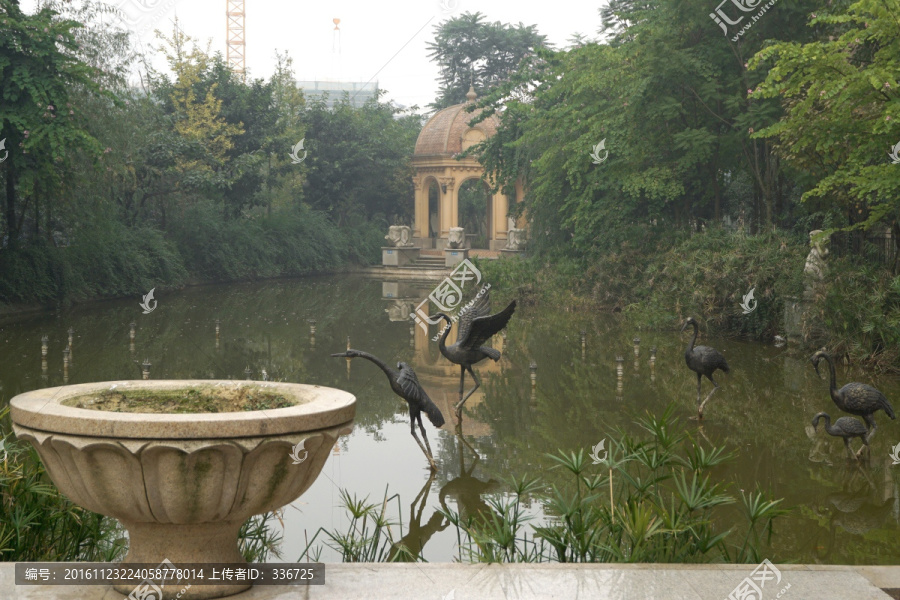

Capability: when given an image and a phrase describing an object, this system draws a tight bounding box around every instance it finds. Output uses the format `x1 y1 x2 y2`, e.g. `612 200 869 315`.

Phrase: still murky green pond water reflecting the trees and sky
0 276 900 564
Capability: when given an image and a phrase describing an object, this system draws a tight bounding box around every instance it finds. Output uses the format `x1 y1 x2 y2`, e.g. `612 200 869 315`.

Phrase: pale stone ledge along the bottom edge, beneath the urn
0 563 900 600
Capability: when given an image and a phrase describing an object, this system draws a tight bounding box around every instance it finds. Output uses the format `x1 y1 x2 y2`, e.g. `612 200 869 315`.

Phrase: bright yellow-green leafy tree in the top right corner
751 0 900 234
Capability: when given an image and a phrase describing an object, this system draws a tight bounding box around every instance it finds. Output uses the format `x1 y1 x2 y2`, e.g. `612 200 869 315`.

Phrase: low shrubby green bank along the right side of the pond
478 228 900 373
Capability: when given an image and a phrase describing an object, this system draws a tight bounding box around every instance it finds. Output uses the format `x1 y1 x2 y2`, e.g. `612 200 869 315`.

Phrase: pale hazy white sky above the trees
21 0 605 109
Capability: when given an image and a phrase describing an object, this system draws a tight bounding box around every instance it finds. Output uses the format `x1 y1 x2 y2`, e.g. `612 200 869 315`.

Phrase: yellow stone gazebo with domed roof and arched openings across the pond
412 87 524 250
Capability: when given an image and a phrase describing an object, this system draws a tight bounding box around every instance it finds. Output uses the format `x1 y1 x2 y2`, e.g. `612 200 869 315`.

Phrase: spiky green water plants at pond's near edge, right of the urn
445 404 787 563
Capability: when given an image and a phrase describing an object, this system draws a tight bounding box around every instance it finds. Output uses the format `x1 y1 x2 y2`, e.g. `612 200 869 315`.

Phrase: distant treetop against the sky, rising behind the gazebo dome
428 12 546 110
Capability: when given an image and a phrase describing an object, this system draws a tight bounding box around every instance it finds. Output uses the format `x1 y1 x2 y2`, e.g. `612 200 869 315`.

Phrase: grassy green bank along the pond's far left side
0 202 384 307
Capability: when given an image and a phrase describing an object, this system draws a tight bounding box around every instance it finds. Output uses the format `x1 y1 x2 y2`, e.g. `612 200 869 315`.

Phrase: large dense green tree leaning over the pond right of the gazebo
476 0 824 256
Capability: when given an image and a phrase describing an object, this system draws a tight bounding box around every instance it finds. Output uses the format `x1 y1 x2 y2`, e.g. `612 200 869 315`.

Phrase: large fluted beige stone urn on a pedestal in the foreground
10 380 356 600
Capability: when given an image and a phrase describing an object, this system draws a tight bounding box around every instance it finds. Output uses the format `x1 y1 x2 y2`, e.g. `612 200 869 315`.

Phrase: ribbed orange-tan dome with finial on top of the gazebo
414 88 500 156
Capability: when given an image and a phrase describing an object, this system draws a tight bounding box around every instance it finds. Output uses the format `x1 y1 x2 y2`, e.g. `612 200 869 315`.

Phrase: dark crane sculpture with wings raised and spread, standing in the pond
429 292 516 421
